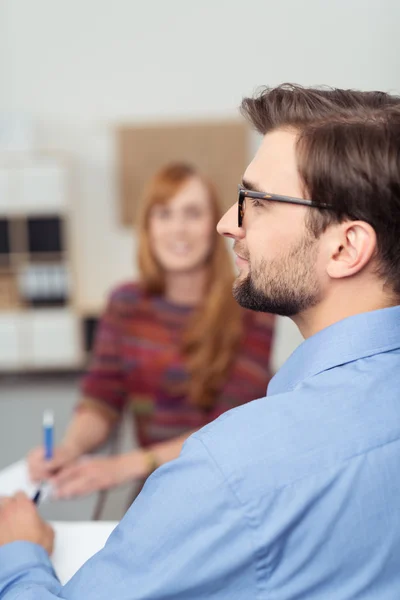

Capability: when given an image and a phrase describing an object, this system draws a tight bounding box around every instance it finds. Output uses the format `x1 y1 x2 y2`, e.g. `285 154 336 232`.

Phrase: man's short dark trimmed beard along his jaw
233 234 320 317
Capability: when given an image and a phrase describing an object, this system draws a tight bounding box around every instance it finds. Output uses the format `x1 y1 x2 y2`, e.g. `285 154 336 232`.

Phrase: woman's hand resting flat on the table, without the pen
50 450 148 498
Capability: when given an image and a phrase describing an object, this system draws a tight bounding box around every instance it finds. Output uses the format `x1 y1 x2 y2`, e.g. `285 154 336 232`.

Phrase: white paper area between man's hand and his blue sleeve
51 521 117 584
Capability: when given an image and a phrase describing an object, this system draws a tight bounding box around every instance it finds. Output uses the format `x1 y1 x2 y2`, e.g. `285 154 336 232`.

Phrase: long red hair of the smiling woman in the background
138 163 242 410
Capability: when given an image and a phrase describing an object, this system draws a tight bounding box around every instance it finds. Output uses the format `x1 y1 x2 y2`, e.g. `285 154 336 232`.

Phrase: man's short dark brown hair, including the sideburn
241 84 400 297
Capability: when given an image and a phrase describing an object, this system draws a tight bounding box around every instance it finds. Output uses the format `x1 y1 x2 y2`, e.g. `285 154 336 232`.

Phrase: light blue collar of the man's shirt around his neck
268 306 400 396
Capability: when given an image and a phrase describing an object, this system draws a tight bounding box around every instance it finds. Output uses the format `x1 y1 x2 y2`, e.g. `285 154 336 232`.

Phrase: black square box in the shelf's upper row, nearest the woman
28 217 64 253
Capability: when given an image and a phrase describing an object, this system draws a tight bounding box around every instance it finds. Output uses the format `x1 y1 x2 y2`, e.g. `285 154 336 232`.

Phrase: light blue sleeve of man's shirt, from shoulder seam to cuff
0 436 257 600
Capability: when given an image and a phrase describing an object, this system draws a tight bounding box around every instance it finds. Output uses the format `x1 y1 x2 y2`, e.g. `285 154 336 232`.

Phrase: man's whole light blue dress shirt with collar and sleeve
0 307 400 600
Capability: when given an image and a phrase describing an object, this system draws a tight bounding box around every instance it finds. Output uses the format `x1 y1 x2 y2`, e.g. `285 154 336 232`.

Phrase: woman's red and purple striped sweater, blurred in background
82 283 274 446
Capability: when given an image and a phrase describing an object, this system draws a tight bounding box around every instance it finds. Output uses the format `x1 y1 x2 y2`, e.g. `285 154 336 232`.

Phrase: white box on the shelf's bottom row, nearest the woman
26 308 81 368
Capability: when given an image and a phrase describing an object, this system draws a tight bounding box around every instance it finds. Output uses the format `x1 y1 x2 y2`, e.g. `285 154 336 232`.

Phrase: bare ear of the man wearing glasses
327 221 377 279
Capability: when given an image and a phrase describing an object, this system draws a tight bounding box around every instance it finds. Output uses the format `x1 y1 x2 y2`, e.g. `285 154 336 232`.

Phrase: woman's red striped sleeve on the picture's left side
77 293 126 419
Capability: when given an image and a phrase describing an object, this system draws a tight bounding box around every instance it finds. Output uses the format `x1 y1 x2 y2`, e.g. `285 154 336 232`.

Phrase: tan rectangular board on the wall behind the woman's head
117 120 249 225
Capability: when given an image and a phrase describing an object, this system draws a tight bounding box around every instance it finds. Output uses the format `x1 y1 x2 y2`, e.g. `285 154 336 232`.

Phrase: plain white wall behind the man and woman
0 0 400 360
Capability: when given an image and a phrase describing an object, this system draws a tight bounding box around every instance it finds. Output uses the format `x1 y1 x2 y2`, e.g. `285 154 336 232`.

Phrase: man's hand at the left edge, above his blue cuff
0 492 54 554
